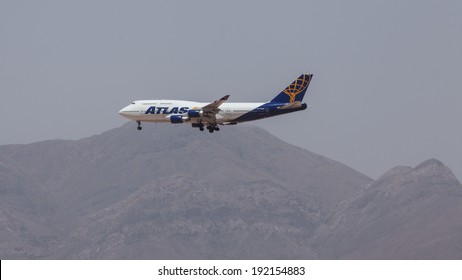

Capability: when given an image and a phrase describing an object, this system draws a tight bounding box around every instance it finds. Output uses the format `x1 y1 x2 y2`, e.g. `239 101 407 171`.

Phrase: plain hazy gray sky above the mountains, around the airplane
0 0 462 179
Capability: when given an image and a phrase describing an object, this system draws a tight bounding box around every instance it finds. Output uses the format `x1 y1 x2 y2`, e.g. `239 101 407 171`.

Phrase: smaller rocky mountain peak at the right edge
312 159 462 259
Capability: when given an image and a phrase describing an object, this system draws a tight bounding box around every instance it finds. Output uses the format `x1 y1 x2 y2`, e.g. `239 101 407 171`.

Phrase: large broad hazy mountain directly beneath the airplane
0 123 372 259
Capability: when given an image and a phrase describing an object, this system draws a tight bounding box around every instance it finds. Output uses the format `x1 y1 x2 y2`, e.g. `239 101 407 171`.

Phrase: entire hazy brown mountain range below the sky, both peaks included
0 123 462 259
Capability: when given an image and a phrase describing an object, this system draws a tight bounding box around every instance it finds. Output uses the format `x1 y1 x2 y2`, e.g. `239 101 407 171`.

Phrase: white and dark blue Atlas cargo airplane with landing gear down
119 74 313 133
